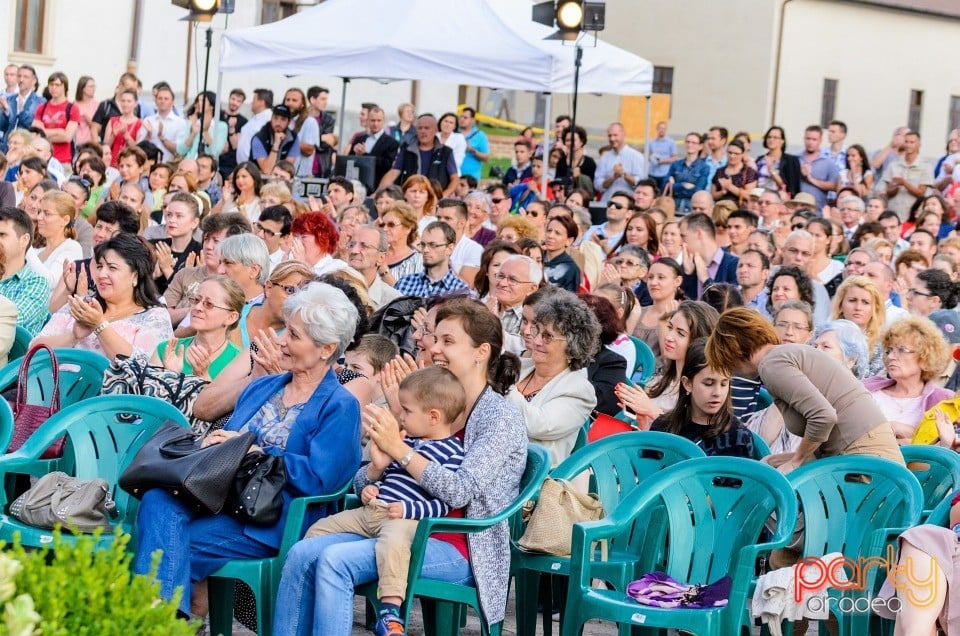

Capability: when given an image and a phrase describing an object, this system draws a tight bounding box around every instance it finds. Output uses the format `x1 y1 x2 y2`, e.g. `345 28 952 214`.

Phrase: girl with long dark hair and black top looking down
650 338 753 458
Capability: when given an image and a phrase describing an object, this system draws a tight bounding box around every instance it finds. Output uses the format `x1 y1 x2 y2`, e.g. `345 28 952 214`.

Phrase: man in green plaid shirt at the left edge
0 208 50 336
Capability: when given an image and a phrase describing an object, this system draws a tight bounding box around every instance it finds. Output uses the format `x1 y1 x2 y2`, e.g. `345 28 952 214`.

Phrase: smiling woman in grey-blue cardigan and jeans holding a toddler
274 300 527 636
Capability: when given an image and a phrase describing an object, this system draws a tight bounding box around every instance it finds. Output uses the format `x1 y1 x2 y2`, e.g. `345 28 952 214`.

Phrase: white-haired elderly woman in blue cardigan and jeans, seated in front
134 283 360 618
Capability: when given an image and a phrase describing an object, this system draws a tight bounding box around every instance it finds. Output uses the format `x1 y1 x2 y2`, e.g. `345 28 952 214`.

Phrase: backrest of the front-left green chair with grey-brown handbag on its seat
41 395 189 523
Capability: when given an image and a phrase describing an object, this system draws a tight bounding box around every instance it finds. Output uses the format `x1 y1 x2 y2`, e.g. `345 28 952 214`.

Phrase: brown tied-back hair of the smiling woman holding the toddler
437 299 520 395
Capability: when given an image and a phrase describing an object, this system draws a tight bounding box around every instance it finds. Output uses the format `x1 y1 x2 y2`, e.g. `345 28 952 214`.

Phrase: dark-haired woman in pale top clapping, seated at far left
34 234 173 360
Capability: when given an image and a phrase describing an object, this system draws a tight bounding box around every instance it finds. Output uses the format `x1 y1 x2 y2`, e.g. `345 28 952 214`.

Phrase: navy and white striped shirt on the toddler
376 436 463 519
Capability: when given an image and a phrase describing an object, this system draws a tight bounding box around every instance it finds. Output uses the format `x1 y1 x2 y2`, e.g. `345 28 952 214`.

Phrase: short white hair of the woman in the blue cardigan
283 283 359 360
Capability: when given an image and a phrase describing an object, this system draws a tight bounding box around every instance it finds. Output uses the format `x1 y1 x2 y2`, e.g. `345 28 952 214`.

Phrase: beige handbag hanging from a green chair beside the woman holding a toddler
517 477 606 556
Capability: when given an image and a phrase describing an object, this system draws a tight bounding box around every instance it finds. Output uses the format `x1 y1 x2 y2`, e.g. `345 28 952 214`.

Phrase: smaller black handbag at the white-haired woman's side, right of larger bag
225 451 287 526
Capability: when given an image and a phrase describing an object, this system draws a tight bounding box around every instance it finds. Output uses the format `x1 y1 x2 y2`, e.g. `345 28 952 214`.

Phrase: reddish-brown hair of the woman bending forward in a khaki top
706 307 780 375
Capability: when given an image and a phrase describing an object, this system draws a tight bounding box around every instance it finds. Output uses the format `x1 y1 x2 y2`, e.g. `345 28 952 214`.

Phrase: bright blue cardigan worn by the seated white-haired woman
224 370 360 548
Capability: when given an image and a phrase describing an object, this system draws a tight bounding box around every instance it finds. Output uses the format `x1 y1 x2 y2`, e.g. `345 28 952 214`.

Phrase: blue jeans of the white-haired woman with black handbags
133 489 277 614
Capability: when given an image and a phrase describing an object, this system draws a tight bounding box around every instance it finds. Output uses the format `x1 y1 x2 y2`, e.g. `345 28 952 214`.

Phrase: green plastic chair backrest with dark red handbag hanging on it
0 349 110 408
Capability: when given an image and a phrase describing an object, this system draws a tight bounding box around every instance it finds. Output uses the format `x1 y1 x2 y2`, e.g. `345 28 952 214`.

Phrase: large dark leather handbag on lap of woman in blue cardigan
119 424 256 514
